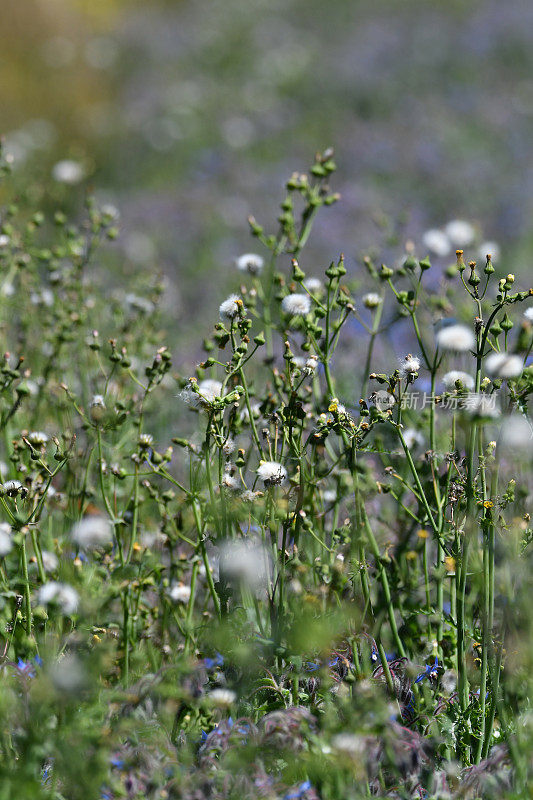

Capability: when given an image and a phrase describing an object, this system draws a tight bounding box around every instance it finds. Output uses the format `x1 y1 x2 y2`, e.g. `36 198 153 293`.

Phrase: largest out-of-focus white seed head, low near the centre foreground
218 539 272 592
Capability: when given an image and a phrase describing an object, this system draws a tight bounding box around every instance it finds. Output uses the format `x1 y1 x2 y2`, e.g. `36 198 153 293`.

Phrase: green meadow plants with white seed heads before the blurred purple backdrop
0 145 533 800
